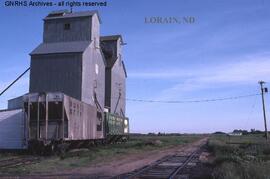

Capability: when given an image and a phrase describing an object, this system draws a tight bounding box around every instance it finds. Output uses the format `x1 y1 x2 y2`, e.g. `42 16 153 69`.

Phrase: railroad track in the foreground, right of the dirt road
117 146 202 179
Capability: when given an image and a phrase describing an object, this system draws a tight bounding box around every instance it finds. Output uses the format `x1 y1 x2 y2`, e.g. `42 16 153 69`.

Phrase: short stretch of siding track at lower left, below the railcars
0 157 40 169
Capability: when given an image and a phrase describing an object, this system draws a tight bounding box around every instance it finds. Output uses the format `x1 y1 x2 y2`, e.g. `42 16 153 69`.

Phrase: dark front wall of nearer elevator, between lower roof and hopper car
29 53 82 100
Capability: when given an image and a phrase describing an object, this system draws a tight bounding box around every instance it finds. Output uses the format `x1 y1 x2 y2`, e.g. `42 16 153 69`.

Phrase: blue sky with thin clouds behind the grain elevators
0 0 270 133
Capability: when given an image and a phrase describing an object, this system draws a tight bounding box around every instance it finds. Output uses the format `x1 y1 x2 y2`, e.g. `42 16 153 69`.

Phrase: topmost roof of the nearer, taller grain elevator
44 11 101 23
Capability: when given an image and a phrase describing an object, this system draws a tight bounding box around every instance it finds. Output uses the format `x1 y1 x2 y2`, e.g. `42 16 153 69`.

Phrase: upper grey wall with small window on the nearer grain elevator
43 16 92 43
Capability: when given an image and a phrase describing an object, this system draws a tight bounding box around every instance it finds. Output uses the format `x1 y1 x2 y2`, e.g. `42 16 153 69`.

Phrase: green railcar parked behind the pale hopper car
104 112 129 135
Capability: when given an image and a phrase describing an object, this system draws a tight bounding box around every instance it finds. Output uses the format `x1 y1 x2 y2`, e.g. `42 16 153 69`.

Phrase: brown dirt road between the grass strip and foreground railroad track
53 138 207 178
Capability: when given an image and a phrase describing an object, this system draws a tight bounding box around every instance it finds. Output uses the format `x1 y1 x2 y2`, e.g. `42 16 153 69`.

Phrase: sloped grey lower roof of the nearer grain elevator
30 41 91 55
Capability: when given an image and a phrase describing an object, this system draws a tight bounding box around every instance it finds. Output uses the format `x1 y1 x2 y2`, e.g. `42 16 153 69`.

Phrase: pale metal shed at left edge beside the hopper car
0 109 27 149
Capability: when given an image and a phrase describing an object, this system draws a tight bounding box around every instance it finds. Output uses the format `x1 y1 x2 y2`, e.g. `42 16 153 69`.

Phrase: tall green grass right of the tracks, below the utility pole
208 135 270 179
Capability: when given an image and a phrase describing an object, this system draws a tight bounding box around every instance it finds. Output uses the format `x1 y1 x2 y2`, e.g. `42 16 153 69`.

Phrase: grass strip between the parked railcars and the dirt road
0 135 202 174
